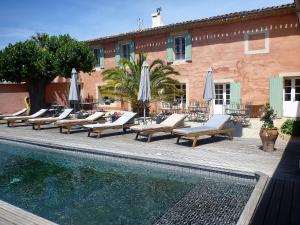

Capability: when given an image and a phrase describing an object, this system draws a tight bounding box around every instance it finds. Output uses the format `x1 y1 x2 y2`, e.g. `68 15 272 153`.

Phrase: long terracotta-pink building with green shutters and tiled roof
0 1 300 117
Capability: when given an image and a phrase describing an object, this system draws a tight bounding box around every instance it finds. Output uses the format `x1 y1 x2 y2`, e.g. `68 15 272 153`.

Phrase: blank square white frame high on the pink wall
244 30 270 55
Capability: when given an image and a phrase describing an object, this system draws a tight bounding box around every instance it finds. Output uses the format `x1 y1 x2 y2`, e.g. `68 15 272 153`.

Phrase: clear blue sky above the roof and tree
0 0 294 49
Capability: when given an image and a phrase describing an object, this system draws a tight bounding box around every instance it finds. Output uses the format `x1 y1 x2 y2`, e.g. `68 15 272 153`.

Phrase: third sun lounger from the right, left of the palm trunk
84 112 136 138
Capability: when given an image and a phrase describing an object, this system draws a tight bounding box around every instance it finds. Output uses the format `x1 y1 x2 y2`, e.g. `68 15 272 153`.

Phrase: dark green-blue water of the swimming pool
0 140 256 225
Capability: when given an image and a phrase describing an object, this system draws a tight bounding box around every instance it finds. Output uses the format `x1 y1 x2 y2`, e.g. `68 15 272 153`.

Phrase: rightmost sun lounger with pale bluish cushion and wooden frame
173 115 233 147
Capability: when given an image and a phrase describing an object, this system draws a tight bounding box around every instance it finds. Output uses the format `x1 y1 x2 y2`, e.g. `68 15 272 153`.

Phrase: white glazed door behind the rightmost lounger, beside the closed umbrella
214 84 230 114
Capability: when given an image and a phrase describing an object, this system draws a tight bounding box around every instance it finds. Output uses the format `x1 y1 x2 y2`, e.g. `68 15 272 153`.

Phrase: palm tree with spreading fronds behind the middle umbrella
100 53 181 115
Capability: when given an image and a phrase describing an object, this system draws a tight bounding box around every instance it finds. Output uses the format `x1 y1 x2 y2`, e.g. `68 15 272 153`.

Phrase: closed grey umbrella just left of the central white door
203 68 216 115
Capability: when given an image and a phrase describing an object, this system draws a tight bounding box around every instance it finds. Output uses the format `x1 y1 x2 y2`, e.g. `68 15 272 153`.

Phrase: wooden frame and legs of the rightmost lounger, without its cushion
175 128 233 148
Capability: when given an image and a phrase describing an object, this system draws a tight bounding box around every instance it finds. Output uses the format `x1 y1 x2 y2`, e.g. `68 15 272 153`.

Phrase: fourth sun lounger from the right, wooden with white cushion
54 112 105 134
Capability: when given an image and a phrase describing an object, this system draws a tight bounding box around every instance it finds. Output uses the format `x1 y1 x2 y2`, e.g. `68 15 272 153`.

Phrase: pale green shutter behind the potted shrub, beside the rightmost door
269 77 283 118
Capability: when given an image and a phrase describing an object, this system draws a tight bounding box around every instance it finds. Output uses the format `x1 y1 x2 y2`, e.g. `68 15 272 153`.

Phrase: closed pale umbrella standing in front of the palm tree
138 61 151 123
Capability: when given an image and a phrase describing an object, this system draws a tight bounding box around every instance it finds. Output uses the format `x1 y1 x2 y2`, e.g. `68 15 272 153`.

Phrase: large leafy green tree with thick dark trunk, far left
0 33 96 113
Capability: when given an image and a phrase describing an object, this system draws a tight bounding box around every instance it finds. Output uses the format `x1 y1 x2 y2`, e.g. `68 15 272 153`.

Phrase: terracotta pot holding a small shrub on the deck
259 127 278 152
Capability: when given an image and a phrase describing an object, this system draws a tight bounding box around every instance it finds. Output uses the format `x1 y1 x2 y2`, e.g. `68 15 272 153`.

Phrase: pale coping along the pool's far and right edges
0 135 269 225
